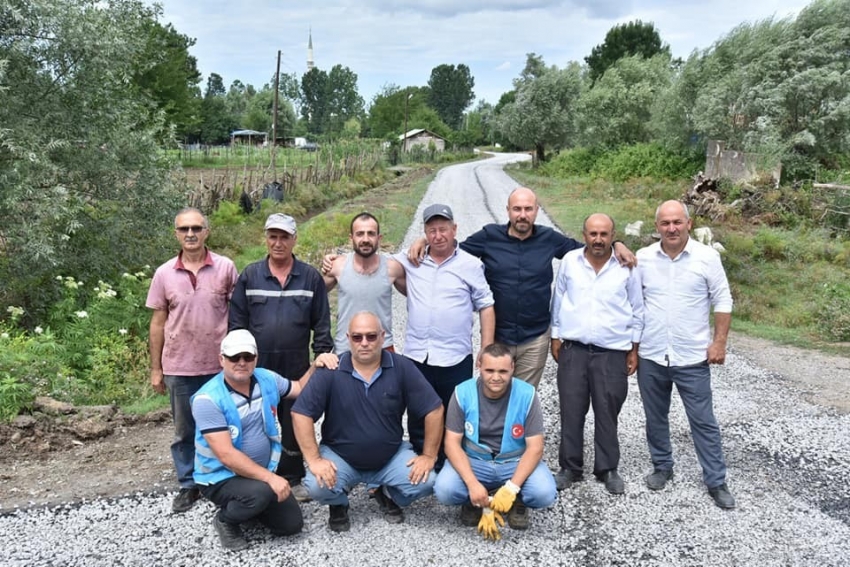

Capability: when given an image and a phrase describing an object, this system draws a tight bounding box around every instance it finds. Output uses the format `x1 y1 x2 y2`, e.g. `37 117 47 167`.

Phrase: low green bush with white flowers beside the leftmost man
0 267 153 419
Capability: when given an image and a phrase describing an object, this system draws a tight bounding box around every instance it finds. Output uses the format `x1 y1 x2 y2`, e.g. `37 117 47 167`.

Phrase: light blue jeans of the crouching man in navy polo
304 441 434 507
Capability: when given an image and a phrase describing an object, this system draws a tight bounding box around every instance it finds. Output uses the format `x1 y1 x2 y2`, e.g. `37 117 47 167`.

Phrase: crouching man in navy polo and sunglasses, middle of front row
292 312 443 532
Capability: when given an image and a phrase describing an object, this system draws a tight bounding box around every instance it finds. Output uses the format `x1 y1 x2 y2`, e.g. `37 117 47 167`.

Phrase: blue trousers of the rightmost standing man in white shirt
638 358 726 488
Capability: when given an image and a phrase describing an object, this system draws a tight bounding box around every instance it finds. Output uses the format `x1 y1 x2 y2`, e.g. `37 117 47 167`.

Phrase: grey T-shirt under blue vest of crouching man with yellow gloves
446 380 545 454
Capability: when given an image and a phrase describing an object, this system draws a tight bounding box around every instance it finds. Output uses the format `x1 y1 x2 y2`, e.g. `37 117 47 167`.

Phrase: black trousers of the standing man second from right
558 341 629 476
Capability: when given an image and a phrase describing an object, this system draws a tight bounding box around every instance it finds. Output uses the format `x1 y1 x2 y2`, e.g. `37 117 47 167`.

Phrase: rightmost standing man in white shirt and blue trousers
637 201 735 509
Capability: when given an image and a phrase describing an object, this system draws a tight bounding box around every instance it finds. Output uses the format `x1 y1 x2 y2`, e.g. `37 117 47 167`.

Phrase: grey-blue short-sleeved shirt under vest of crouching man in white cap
192 374 292 467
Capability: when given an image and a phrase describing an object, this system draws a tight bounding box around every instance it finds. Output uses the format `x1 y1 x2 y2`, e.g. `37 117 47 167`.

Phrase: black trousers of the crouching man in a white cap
199 476 304 535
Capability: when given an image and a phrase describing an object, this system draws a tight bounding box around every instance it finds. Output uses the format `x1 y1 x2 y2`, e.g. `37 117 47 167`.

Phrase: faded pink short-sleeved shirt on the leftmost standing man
145 250 239 376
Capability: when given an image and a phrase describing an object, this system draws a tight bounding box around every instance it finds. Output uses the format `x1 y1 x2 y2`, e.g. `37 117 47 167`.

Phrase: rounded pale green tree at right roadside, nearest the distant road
498 57 582 161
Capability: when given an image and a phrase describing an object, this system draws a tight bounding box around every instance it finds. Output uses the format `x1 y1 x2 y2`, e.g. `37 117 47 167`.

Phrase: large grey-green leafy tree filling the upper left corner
0 0 184 321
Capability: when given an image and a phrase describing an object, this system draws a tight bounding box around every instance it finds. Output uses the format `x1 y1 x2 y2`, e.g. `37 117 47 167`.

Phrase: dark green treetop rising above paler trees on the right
584 20 670 82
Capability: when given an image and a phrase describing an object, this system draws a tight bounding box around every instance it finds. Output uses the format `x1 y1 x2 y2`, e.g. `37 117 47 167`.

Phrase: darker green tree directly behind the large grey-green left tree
133 18 201 144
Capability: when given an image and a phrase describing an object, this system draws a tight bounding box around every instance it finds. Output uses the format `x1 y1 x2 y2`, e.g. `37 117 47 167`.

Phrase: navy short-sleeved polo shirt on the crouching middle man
292 351 442 470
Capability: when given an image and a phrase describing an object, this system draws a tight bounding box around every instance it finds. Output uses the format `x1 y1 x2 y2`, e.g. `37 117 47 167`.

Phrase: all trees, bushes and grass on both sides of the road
0 0 850 419
